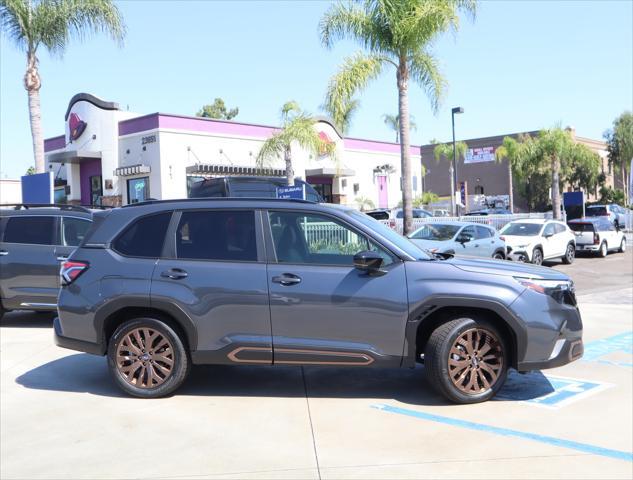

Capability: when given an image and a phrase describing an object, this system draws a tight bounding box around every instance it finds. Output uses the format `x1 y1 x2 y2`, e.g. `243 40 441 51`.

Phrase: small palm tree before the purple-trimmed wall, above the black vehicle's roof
257 101 336 186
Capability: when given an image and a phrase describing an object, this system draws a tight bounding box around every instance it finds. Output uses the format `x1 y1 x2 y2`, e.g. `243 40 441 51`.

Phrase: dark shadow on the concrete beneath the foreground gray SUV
16 354 553 406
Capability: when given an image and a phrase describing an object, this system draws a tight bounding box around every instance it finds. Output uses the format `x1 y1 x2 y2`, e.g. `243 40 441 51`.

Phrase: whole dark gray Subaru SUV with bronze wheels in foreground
54 198 583 403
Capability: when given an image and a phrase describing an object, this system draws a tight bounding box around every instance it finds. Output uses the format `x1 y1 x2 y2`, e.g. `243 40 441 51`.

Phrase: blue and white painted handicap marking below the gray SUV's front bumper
495 371 613 409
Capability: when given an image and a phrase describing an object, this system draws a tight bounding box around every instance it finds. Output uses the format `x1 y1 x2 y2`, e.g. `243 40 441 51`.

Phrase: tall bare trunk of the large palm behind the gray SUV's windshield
397 59 413 235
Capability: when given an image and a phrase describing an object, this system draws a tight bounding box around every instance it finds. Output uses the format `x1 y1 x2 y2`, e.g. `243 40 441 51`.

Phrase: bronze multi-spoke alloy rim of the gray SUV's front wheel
448 328 503 395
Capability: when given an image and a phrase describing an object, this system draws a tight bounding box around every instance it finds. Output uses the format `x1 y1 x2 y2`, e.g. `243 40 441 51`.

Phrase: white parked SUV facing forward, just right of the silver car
499 219 576 265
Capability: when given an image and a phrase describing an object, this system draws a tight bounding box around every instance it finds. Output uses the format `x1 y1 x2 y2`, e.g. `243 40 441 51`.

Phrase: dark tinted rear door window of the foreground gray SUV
176 210 257 262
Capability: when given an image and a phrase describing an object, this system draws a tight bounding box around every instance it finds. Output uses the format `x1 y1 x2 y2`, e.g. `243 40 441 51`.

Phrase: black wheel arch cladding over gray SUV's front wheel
403 297 527 368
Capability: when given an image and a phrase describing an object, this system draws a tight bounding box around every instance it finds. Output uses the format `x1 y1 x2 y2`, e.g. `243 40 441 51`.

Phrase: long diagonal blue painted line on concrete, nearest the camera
372 404 633 462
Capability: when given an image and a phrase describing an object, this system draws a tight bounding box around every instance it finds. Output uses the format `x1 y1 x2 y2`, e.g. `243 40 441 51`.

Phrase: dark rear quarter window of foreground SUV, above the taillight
114 212 171 258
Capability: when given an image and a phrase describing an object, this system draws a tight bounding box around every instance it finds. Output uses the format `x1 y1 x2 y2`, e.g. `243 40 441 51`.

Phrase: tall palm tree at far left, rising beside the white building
0 0 125 172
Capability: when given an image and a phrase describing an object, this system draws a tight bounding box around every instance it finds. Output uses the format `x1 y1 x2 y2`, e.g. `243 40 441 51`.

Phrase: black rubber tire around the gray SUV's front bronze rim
424 317 508 404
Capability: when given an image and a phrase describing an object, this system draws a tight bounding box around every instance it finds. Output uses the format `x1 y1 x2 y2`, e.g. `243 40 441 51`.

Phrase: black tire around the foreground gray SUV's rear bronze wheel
108 318 191 398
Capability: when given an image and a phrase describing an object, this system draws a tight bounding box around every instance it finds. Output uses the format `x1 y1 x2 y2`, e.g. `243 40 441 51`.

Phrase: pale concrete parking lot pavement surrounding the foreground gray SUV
0 249 633 479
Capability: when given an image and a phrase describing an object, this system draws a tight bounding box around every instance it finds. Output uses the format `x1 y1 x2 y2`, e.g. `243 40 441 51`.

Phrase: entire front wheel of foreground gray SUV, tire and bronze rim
424 318 508 404
